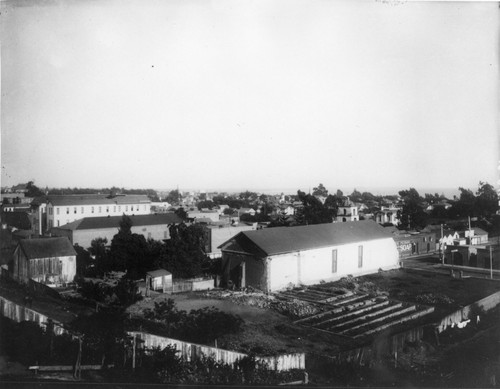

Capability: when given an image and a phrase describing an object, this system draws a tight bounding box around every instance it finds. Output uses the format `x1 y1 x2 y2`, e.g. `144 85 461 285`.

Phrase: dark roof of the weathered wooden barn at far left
19 238 76 259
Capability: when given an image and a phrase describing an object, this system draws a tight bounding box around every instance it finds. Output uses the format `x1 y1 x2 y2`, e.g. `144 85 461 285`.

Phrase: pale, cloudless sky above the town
1 0 500 196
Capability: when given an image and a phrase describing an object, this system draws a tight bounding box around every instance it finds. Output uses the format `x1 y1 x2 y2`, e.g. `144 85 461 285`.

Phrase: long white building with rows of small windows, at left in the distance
46 194 151 229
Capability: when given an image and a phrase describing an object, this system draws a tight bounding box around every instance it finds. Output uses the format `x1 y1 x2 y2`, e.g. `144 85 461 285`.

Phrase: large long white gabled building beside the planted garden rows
220 220 399 292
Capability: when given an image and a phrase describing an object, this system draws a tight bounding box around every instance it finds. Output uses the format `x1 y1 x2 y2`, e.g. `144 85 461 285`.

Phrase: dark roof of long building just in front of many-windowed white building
54 213 182 231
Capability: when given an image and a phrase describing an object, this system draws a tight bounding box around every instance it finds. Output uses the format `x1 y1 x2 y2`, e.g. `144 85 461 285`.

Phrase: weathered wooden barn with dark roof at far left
11 238 76 285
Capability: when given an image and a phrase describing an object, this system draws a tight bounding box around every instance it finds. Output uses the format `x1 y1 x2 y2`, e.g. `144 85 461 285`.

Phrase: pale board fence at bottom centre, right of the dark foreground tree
128 331 305 371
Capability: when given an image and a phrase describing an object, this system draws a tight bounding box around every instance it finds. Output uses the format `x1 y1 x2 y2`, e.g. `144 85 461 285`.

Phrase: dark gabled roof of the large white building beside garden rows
219 220 392 256
